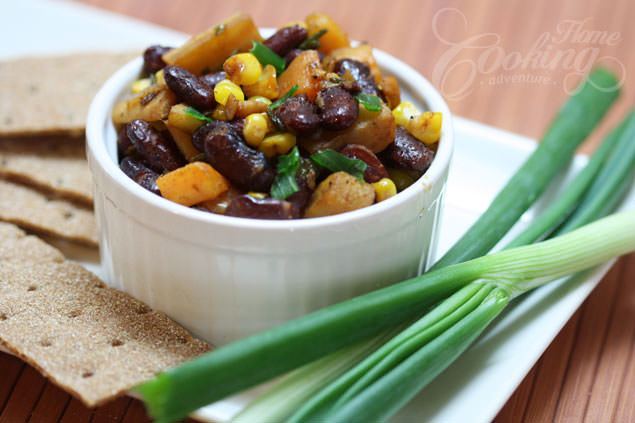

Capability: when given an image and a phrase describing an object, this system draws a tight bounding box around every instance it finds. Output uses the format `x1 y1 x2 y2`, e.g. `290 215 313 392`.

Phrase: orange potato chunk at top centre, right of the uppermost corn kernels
278 50 320 101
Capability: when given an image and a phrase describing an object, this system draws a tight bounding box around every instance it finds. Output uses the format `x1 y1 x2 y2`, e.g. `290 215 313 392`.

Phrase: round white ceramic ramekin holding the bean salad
86 39 453 345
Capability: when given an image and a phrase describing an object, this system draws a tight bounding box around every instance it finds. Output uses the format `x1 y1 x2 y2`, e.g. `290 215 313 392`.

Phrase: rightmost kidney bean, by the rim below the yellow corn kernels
380 126 434 172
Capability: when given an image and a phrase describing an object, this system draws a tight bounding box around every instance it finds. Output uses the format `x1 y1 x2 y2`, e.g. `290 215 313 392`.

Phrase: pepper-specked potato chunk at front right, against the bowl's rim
304 172 375 217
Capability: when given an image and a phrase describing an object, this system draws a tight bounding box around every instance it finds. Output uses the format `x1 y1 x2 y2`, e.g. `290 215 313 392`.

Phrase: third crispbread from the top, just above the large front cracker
0 180 99 246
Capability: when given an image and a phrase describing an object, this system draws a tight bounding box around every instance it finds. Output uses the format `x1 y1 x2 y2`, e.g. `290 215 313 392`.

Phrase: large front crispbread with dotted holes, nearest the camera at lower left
0 223 210 406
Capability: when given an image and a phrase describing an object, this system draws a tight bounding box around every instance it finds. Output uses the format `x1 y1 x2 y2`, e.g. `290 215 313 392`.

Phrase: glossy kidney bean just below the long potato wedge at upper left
163 66 216 111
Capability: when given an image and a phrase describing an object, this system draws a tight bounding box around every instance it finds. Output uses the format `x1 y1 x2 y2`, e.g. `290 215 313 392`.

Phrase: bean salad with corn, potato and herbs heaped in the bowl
112 13 442 219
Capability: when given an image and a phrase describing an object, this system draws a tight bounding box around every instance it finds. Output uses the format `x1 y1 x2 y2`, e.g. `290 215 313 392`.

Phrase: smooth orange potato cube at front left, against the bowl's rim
157 162 230 206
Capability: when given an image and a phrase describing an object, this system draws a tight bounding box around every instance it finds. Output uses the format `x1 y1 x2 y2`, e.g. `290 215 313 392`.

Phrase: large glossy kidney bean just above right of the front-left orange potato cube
199 124 274 192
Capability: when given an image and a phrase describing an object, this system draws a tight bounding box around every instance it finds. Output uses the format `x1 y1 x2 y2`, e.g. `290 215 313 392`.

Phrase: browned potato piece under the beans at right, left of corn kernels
300 104 395 154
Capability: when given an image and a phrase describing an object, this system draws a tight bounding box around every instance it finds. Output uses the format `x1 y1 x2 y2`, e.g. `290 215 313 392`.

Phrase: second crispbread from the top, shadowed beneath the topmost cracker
0 136 93 206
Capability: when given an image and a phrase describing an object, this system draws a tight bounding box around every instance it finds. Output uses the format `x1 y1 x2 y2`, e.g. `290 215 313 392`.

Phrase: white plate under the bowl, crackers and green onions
0 0 635 423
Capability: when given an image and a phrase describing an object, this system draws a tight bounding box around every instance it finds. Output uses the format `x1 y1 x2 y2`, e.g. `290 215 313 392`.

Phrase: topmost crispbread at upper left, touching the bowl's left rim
0 53 139 136
